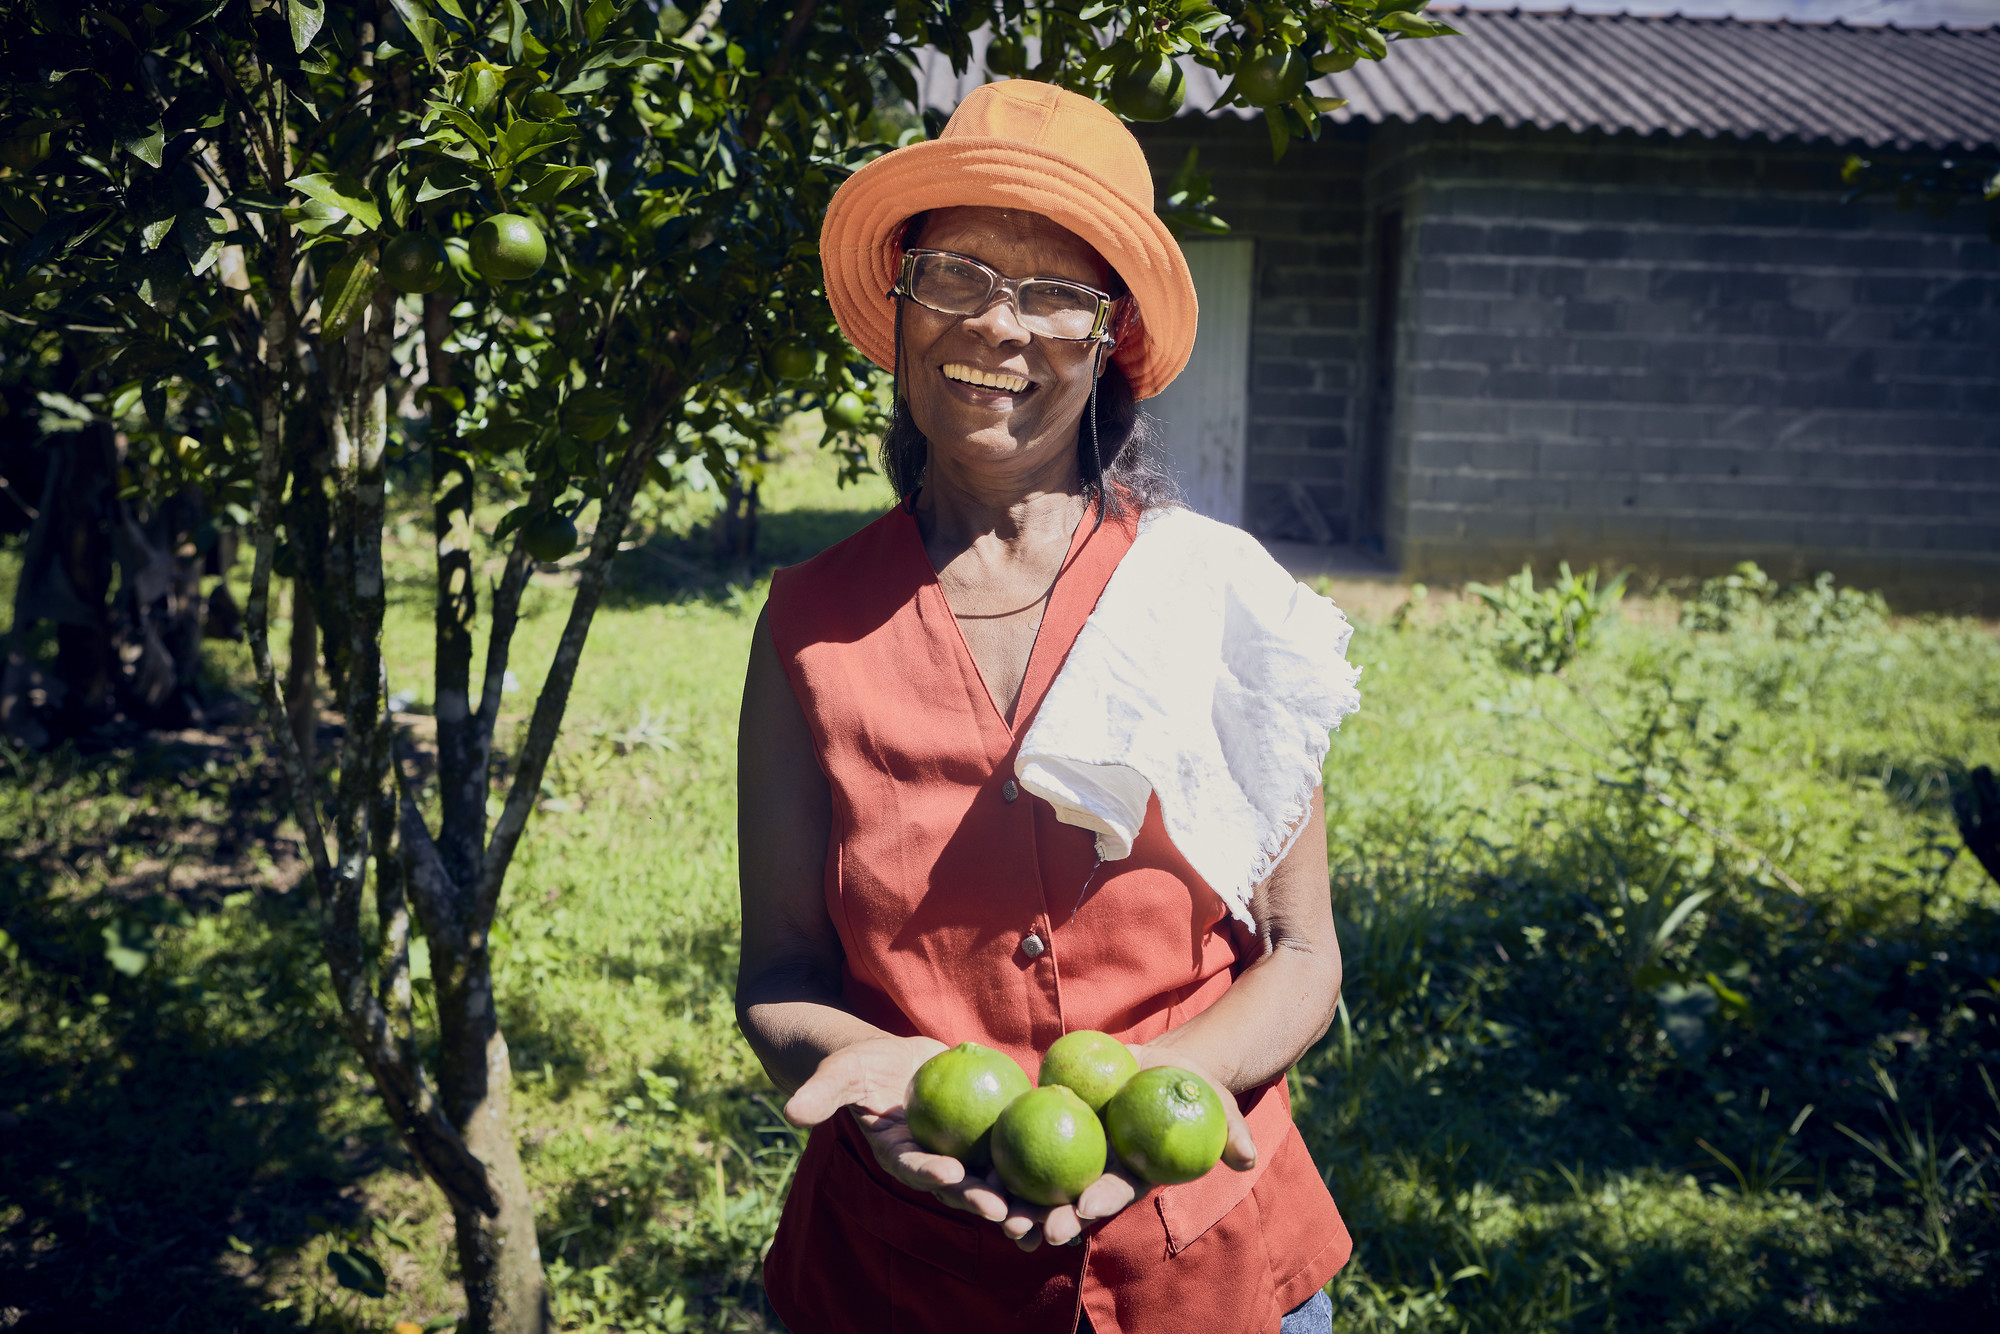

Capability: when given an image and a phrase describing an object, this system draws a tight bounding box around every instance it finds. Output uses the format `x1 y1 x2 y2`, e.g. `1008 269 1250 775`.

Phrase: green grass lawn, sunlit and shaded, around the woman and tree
0 434 2000 1332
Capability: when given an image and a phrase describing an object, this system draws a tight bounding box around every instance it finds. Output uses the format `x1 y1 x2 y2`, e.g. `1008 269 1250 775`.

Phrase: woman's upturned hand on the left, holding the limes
784 1038 1008 1222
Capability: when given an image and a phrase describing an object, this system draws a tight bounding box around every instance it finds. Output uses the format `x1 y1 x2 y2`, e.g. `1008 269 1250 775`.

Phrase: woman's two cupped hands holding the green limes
784 1038 1256 1250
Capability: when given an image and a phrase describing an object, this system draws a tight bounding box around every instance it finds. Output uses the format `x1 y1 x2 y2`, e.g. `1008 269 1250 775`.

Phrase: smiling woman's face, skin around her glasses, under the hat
902 208 1112 482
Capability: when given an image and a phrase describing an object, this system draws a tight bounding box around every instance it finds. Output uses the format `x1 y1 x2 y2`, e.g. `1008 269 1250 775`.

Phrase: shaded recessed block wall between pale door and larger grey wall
1136 116 1368 544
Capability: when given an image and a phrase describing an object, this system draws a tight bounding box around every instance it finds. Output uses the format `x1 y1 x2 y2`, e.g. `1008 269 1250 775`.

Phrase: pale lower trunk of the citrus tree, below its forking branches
432 944 556 1334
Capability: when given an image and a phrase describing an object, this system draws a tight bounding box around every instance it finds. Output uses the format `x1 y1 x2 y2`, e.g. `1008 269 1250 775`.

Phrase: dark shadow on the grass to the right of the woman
1296 830 2000 1332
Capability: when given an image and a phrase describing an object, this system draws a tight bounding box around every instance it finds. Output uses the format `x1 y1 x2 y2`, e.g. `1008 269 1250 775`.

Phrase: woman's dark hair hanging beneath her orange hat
882 212 1184 518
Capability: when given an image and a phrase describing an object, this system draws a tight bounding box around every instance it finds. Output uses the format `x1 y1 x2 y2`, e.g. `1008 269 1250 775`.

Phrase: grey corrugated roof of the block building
924 6 2000 152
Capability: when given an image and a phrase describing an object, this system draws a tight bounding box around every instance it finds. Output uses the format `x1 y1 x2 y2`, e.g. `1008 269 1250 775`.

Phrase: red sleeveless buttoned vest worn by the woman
764 508 1350 1334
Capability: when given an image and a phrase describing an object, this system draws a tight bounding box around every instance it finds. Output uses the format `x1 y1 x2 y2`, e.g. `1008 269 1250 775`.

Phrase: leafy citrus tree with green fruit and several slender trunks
0 0 1446 1330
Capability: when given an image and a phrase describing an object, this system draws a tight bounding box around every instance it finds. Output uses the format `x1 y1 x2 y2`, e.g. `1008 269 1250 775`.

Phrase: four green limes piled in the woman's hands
904 1030 1228 1204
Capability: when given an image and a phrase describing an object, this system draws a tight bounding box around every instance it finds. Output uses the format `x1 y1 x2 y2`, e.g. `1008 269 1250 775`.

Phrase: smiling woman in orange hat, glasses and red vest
736 80 1352 1334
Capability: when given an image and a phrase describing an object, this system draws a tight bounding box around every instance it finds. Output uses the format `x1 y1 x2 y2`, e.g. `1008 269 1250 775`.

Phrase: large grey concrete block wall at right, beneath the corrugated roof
1366 124 2000 610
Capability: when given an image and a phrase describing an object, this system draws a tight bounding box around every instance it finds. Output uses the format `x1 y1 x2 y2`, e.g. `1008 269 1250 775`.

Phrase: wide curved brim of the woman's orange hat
820 136 1198 398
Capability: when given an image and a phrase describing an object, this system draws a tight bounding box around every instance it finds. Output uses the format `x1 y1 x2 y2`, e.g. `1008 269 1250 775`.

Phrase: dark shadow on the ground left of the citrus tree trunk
0 738 400 1332
